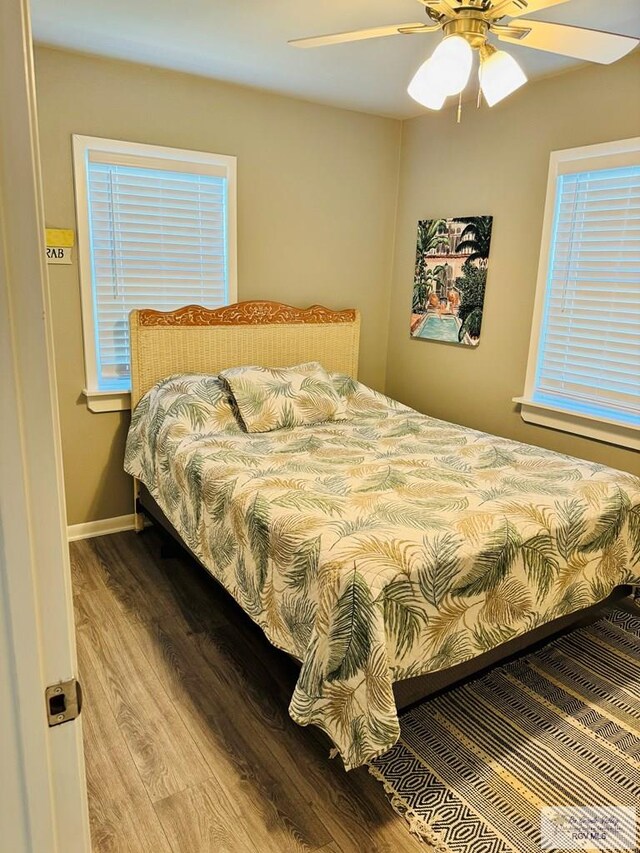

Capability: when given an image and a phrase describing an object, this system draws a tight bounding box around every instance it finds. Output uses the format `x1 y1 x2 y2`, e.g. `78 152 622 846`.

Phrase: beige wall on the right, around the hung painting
386 51 640 480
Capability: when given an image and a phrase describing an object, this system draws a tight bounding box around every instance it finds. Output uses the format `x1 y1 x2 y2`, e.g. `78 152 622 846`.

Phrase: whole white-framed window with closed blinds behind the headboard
73 136 237 411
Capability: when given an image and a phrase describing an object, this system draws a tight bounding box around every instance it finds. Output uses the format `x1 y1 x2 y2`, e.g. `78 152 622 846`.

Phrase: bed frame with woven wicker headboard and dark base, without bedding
130 301 631 711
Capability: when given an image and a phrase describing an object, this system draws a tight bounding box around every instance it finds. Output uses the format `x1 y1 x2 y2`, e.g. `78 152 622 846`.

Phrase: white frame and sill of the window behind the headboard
72 134 238 412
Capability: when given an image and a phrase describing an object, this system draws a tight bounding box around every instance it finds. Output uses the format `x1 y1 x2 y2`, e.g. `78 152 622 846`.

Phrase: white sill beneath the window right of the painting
513 397 640 450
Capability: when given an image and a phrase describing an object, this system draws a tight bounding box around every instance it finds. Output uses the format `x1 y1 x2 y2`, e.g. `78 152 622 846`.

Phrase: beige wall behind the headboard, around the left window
36 47 400 524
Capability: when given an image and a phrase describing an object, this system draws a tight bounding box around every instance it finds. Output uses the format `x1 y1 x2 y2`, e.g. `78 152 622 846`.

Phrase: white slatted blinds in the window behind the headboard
83 143 230 391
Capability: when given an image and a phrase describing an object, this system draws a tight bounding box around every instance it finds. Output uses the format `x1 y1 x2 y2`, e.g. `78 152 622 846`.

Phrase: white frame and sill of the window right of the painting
513 137 640 450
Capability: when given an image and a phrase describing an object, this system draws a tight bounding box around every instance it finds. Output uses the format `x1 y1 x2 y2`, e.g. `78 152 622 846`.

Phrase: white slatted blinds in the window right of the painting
533 166 640 425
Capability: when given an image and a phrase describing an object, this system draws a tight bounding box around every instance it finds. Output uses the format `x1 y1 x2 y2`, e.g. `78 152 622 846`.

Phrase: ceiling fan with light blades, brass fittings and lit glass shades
289 0 640 110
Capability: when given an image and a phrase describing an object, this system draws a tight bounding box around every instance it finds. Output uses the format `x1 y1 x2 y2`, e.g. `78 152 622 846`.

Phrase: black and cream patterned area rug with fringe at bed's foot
369 610 640 853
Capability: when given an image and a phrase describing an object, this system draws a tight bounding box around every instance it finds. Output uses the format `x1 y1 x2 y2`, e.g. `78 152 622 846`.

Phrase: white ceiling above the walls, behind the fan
31 0 640 118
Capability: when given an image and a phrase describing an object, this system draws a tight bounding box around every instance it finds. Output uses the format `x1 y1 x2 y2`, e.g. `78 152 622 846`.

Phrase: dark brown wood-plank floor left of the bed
71 530 425 853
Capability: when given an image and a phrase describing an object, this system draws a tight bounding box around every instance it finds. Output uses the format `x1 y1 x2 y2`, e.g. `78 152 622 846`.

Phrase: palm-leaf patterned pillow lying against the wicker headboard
220 361 347 432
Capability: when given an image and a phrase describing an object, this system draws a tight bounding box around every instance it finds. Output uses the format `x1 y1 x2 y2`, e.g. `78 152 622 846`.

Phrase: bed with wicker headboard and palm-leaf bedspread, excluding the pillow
125 302 640 769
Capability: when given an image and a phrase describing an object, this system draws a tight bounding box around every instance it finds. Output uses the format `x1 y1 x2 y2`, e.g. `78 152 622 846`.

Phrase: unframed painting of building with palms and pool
411 216 493 346
